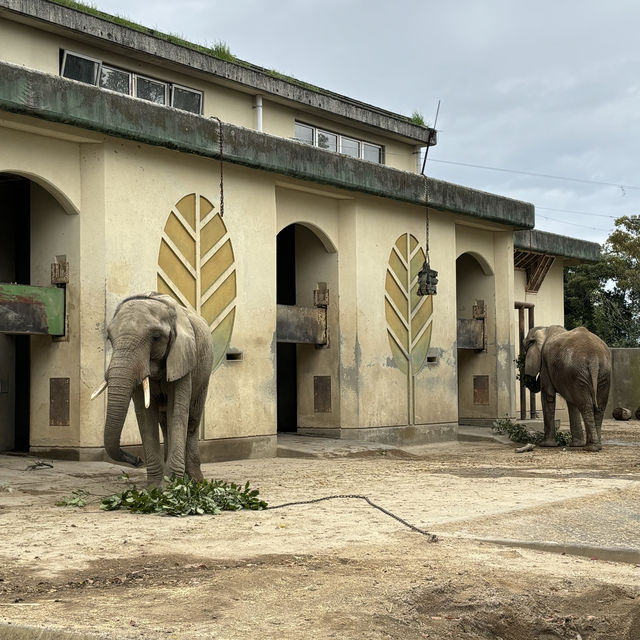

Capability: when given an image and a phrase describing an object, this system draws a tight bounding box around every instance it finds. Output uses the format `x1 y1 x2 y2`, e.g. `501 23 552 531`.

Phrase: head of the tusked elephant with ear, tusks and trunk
92 293 196 466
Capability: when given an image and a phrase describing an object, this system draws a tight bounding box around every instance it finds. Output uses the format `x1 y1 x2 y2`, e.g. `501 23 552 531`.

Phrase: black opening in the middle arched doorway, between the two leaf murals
276 225 298 432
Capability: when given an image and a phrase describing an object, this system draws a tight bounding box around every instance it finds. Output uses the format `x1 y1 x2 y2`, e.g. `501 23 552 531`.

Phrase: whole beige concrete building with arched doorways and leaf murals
0 0 599 460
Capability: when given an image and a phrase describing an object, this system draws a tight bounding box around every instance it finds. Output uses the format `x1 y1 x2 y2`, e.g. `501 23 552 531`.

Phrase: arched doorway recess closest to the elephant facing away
456 253 498 426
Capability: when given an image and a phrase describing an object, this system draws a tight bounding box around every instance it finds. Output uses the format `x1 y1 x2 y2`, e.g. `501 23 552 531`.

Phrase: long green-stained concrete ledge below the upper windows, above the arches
0 63 534 229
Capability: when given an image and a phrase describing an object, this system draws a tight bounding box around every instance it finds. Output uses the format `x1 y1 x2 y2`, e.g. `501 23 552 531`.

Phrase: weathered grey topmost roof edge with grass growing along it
0 0 433 144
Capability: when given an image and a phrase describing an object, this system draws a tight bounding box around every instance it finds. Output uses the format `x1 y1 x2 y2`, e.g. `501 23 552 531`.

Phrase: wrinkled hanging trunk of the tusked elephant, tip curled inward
104 353 148 467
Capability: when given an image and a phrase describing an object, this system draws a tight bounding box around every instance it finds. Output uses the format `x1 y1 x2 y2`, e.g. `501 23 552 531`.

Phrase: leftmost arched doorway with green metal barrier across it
0 171 79 452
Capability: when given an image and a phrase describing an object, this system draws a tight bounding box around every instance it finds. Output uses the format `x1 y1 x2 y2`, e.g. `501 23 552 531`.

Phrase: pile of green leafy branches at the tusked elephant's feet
56 475 267 516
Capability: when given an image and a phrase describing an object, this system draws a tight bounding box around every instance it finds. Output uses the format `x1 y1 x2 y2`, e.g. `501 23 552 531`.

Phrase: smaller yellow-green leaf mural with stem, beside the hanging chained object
385 233 433 424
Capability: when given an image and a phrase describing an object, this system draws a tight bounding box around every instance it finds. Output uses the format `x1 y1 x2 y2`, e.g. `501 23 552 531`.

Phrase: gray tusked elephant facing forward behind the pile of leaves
92 293 213 486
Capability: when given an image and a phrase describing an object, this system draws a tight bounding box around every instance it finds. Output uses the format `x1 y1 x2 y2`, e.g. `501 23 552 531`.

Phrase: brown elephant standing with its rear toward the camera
523 325 611 451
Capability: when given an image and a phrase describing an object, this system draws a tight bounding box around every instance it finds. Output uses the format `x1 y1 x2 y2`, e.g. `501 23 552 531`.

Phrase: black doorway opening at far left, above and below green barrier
0 173 31 452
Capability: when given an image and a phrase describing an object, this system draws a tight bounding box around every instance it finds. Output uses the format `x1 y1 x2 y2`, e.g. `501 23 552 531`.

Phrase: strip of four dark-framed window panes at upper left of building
60 51 203 115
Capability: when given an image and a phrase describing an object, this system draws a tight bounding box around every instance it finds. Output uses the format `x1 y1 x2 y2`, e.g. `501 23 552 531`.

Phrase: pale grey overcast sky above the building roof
95 0 640 243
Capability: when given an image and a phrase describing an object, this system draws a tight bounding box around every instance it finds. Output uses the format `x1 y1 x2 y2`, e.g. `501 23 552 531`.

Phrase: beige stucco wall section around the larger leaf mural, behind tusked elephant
100 141 275 442
